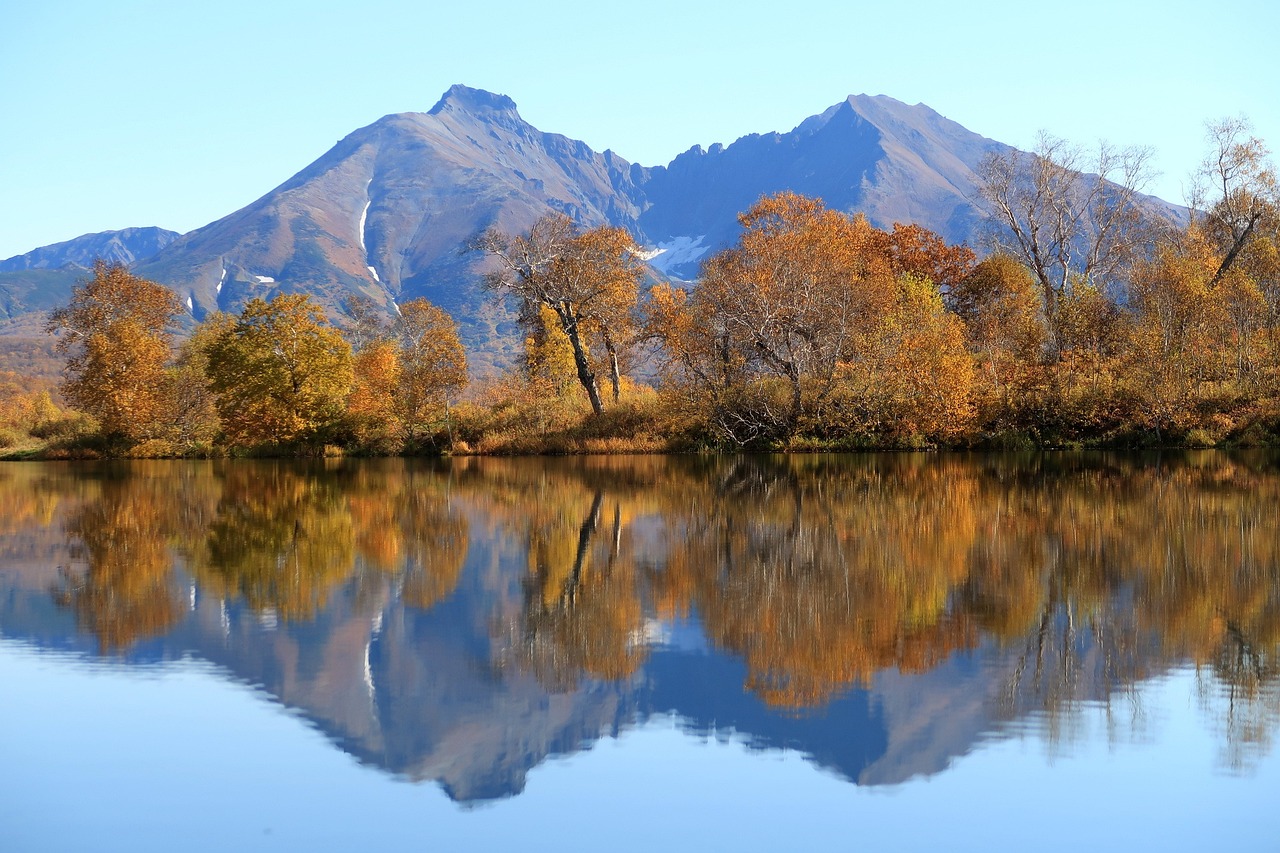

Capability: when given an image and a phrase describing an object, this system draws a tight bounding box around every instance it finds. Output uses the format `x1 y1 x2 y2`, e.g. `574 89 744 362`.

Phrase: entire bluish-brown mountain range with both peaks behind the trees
0 86 1171 365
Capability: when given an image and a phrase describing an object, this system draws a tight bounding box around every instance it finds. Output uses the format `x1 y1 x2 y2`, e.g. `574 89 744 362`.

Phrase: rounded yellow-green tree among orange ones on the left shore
209 293 352 446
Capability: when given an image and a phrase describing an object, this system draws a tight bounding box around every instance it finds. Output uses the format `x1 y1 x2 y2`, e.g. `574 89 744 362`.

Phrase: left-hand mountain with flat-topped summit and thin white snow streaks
138 86 640 368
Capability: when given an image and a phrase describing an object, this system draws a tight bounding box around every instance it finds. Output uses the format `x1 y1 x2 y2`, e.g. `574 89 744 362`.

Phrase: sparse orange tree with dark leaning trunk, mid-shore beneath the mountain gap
472 214 644 415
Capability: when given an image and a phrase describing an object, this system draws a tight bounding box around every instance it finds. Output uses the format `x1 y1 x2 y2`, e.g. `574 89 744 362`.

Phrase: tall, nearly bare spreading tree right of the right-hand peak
978 133 1152 350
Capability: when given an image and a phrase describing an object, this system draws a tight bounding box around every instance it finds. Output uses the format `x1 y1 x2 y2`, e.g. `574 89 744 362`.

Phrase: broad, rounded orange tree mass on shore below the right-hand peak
646 192 972 444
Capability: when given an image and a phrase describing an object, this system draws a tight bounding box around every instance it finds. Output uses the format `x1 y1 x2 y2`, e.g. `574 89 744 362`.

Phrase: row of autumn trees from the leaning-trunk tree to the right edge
477 120 1280 447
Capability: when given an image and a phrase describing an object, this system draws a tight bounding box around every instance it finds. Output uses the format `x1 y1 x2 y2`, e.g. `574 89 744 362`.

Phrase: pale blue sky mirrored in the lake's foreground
0 640 1280 852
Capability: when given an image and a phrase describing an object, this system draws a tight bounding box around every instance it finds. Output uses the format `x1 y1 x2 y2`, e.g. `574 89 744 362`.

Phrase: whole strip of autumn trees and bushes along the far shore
0 120 1280 460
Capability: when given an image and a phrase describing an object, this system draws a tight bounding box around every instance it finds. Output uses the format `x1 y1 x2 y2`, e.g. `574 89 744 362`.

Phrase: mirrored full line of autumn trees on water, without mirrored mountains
12 453 1280 763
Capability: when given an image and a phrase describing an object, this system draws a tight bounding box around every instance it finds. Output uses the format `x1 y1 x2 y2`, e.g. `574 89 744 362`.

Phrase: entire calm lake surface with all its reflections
0 452 1280 852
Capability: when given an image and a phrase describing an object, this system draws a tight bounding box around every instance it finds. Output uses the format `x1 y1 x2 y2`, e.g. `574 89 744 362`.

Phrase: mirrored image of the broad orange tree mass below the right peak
645 457 974 707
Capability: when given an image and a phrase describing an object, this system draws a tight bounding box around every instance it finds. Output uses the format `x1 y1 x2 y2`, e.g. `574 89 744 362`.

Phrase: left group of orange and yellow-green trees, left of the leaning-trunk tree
47 261 466 455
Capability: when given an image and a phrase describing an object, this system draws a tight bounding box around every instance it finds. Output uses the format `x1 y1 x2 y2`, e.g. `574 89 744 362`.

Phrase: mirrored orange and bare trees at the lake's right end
960 455 1280 753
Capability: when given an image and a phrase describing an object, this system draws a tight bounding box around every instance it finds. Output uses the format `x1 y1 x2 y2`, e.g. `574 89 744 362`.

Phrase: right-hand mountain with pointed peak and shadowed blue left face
640 95 1007 278
